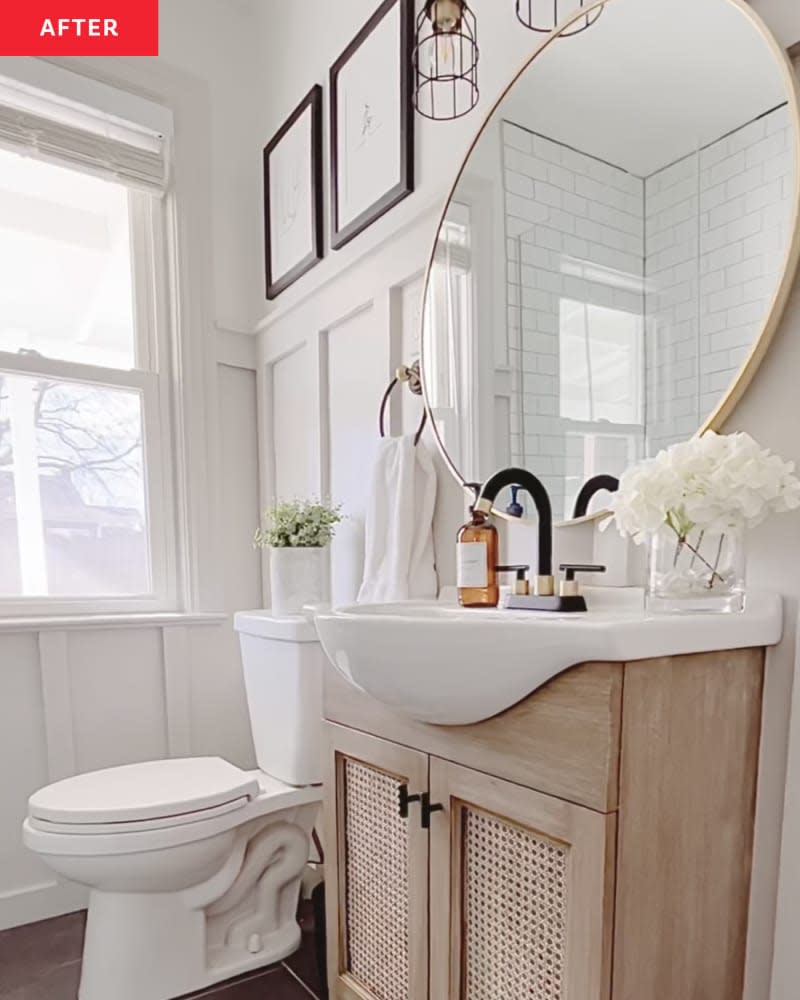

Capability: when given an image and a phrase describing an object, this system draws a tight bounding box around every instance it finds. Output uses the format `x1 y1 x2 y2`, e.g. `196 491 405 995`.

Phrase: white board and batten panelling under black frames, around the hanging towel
258 207 463 604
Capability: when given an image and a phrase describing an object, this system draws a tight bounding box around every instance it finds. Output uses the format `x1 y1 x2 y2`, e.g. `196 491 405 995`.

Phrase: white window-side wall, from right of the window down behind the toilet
0 0 262 928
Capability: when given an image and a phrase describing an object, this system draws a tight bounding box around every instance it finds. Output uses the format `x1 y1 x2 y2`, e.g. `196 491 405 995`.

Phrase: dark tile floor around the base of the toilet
0 904 324 1000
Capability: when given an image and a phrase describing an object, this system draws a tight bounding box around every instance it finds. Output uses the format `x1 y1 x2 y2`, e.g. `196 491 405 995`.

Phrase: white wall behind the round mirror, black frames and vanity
252 0 800 1000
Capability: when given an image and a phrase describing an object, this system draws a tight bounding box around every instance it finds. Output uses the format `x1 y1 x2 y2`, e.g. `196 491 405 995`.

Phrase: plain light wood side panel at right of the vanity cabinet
614 649 764 1000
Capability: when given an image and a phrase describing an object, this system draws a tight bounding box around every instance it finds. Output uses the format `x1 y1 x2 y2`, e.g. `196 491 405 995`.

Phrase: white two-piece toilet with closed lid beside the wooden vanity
23 612 324 1000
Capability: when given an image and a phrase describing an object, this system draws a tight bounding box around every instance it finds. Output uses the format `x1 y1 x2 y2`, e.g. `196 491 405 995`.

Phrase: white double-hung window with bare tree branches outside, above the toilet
0 76 176 613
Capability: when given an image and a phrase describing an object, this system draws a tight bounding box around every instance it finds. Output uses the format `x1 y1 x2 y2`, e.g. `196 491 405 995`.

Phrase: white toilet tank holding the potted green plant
234 611 325 785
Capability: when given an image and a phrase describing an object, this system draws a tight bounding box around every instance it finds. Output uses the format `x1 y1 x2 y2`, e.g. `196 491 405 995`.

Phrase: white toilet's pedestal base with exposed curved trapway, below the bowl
72 803 318 1000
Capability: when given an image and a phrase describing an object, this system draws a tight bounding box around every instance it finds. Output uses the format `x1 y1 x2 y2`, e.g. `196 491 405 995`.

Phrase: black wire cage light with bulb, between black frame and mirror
414 0 480 121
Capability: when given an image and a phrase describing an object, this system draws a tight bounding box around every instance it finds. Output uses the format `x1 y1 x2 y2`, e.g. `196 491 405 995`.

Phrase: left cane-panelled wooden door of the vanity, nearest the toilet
325 725 428 1000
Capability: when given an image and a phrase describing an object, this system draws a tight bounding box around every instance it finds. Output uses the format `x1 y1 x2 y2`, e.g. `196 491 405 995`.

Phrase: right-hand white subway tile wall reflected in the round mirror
645 107 794 452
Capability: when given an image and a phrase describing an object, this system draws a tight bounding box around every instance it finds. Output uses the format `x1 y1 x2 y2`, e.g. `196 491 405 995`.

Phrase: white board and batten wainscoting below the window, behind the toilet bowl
0 616 219 928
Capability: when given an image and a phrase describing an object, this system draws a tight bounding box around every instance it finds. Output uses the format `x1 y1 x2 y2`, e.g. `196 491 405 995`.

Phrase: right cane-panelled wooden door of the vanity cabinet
429 757 615 1000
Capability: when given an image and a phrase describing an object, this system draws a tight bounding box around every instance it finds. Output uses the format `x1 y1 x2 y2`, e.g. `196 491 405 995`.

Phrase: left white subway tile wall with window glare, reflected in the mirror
510 120 645 517
